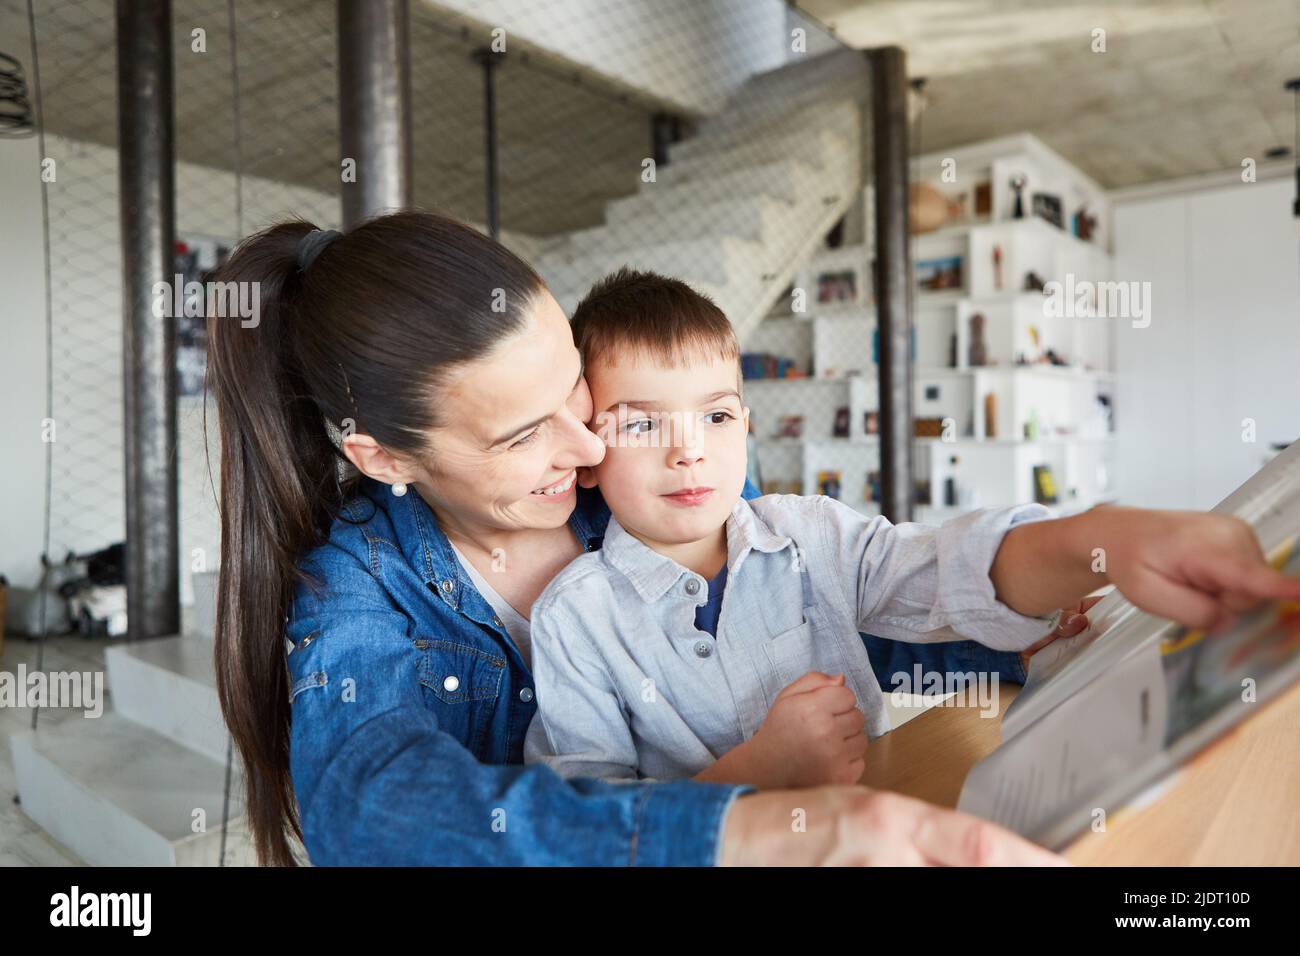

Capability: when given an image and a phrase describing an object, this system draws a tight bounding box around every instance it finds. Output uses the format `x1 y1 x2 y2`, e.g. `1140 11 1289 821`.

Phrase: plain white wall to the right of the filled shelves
1115 178 1300 509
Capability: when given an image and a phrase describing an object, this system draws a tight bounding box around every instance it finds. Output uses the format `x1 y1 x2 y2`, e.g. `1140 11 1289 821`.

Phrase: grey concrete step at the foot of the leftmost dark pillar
104 635 230 763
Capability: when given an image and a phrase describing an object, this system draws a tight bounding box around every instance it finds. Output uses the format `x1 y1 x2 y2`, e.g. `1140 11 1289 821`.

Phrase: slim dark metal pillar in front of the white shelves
867 47 915 523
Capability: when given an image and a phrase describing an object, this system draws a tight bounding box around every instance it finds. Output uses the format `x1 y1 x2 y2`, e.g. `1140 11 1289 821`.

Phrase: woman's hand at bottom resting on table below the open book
720 787 1067 866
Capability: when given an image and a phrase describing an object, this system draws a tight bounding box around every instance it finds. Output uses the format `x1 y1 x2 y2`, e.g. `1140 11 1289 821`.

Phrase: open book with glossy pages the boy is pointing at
958 441 1300 848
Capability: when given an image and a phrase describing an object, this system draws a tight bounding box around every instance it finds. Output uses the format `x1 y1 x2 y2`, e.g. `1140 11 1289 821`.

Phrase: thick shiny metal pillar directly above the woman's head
338 0 412 229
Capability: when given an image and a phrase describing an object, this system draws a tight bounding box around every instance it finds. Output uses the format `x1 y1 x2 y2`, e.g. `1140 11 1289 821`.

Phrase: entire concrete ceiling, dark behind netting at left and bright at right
0 0 1300 235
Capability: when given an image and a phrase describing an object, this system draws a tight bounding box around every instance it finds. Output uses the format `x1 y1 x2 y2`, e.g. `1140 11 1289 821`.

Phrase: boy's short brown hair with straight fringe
572 267 740 375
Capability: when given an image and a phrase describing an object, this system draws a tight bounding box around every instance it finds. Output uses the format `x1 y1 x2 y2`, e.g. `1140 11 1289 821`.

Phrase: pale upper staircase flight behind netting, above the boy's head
534 51 870 343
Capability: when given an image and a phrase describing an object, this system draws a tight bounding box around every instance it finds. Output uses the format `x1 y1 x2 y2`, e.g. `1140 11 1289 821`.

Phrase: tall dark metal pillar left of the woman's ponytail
117 0 181 639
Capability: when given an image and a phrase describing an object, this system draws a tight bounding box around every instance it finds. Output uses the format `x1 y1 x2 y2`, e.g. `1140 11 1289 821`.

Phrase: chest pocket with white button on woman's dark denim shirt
415 639 506 760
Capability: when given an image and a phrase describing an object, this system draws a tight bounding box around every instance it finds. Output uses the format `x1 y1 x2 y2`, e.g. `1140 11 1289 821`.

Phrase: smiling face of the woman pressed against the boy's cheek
415 291 605 532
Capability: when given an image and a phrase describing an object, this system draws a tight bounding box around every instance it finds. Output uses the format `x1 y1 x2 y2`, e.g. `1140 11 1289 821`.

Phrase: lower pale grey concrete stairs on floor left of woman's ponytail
10 575 255 866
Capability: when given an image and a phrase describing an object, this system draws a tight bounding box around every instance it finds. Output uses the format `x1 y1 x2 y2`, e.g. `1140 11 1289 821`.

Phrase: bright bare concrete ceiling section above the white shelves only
797 0 1300 187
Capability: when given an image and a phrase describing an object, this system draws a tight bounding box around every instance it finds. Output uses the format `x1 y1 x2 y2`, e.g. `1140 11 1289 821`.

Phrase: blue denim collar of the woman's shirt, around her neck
359 476 610 610
